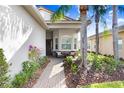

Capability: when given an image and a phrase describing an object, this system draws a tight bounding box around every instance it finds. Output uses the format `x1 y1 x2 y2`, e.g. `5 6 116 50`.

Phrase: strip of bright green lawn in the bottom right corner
81 81 124 88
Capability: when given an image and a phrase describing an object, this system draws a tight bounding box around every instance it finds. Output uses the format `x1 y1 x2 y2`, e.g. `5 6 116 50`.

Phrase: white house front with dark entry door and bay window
0 5 81 77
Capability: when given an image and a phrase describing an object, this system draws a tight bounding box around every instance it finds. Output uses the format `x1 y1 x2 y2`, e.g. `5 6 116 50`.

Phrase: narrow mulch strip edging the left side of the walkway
24 61 50 88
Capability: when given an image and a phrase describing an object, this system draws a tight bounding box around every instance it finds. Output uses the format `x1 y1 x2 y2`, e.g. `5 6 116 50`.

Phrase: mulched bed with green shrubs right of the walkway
64 54 124 88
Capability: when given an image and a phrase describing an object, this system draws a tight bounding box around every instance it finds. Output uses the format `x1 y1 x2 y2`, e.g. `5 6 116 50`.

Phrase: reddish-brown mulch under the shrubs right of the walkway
64 62 124 88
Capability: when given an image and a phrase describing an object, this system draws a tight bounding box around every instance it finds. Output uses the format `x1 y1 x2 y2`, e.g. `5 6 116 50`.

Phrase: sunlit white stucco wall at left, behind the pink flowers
0 6 46 77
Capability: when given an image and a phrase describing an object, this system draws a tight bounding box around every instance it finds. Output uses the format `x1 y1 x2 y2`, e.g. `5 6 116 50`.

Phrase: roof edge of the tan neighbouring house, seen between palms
88 25 124 39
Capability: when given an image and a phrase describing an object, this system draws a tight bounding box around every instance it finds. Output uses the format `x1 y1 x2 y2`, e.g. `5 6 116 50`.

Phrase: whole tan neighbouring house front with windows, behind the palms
88 25 124 58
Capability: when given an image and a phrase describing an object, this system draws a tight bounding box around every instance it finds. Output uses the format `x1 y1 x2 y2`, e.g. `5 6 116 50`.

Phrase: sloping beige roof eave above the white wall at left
23 5 48 29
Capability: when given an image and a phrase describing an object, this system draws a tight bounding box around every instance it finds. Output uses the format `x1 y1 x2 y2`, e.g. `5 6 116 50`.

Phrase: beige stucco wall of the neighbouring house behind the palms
88 31 124 58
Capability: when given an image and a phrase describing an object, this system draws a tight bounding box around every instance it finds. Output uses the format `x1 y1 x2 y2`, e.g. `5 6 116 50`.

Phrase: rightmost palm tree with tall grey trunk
112 5 124 61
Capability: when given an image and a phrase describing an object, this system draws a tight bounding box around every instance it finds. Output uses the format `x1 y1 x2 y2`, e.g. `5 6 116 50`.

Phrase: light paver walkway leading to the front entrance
33 58 67 88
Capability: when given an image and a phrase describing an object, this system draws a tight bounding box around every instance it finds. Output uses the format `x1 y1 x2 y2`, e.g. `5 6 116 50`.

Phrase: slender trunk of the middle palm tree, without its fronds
95 11 99 54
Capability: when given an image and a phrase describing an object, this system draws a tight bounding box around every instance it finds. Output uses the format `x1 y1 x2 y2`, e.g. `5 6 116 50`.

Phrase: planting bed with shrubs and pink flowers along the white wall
0 46 50 88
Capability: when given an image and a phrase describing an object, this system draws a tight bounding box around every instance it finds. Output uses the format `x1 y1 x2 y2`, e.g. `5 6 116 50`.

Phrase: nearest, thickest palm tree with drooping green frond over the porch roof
51 5 88 69
